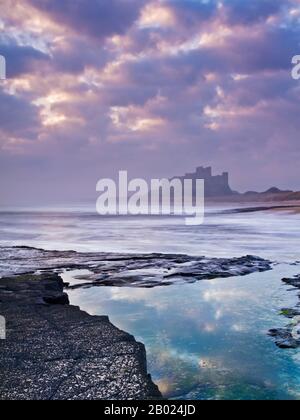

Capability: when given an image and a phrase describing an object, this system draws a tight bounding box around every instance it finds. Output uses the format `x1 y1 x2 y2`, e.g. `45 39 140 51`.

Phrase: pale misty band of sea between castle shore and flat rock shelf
0 206 300 262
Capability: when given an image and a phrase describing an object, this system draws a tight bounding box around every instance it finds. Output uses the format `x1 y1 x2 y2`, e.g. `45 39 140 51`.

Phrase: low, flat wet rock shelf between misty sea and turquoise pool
0 247 271 288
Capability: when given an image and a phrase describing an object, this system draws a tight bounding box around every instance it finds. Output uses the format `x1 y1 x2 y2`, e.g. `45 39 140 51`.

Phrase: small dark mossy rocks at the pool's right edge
269 275 300 349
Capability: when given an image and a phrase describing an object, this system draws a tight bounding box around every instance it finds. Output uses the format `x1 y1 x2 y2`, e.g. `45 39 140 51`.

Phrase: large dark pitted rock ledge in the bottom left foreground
0 272 161 400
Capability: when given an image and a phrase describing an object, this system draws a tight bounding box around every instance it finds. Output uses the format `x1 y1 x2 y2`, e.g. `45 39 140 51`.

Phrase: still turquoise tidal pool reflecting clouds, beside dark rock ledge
70 266 300 399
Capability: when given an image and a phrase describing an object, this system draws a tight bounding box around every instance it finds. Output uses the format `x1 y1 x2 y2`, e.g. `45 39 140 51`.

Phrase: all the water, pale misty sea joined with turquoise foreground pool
0 207 300 400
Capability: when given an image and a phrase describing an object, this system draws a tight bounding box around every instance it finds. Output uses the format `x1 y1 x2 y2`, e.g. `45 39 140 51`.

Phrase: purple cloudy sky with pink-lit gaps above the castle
0 0 300 206
